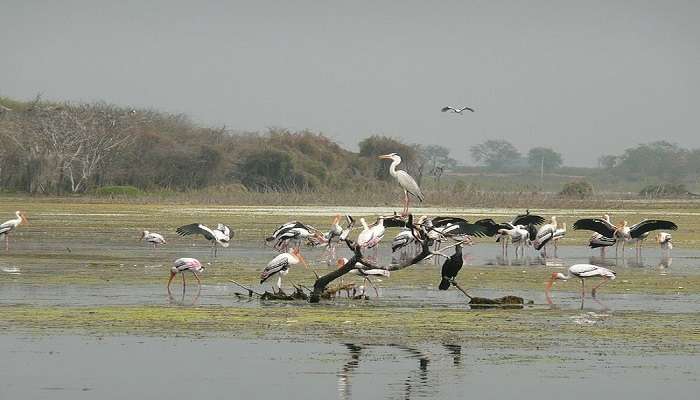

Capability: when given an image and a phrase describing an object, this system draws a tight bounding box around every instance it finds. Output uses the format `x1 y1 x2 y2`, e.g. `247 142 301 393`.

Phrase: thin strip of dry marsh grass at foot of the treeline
5 185 700 210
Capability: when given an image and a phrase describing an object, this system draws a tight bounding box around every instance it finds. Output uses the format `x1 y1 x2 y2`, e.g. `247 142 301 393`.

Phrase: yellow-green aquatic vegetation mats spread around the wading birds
0 198 700 352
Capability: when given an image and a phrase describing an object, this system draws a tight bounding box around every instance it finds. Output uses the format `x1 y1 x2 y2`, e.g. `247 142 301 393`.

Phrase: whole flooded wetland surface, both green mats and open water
0 199 700 398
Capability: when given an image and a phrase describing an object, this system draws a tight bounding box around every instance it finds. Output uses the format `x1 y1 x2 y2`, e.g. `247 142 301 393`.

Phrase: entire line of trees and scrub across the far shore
0 98 700 194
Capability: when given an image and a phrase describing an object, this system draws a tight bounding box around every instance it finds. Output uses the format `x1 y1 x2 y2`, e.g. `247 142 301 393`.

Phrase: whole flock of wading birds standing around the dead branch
0 153 678 301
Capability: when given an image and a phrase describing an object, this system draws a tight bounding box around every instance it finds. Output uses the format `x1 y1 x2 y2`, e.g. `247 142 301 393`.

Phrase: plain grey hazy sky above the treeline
0 0 700 165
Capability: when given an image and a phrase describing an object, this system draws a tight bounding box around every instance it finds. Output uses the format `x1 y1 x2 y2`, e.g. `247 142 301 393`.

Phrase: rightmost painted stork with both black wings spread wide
574 218 678 257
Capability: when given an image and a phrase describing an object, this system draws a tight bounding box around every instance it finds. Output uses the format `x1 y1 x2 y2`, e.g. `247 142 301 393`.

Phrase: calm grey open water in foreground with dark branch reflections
0 335 699 400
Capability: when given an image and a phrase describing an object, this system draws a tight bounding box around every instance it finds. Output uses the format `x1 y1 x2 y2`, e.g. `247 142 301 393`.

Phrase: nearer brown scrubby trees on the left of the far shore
0 98 455 194
